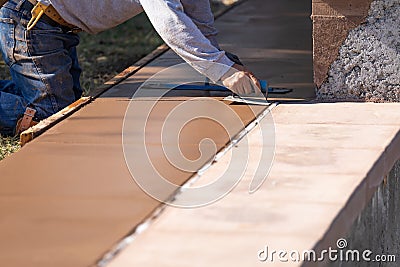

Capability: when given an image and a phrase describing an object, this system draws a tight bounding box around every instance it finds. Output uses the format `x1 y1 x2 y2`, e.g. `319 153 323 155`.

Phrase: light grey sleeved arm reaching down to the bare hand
140 0 233 81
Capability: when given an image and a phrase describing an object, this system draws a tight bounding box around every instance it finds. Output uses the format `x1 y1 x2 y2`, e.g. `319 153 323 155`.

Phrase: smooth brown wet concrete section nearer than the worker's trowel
0 98 264 266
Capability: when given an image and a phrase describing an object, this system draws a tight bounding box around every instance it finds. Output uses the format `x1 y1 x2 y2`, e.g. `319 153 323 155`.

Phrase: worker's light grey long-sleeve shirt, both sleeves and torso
50 0 234 81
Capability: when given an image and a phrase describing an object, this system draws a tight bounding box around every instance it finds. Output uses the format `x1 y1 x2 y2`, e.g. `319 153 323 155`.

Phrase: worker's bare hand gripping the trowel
221 64 261 96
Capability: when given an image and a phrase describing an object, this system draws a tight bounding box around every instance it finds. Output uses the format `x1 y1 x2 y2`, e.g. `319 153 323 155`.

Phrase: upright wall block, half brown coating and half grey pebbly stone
312 0 400 102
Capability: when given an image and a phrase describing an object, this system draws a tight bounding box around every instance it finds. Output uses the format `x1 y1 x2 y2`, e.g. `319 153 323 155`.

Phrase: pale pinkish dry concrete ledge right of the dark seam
107 103 400 267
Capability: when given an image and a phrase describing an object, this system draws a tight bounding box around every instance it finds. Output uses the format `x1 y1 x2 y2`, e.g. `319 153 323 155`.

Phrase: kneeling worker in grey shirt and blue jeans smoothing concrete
0 0 259 135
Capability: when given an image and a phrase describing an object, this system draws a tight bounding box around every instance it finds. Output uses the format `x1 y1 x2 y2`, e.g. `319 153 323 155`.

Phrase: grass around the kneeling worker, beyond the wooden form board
0 3 225 160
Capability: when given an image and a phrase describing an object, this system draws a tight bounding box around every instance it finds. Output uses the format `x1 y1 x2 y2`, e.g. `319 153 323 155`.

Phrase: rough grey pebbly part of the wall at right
317 0 400 102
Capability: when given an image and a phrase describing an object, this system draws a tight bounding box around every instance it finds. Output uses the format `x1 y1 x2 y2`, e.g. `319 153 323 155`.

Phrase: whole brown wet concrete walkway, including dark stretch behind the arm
0 0 314 267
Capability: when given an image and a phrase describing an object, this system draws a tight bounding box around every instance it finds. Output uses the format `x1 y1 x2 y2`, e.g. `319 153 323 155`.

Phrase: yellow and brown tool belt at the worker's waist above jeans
22 0 82 33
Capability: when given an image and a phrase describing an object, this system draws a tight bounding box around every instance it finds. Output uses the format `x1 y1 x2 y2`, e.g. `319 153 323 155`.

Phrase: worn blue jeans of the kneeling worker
0 0 82 135
